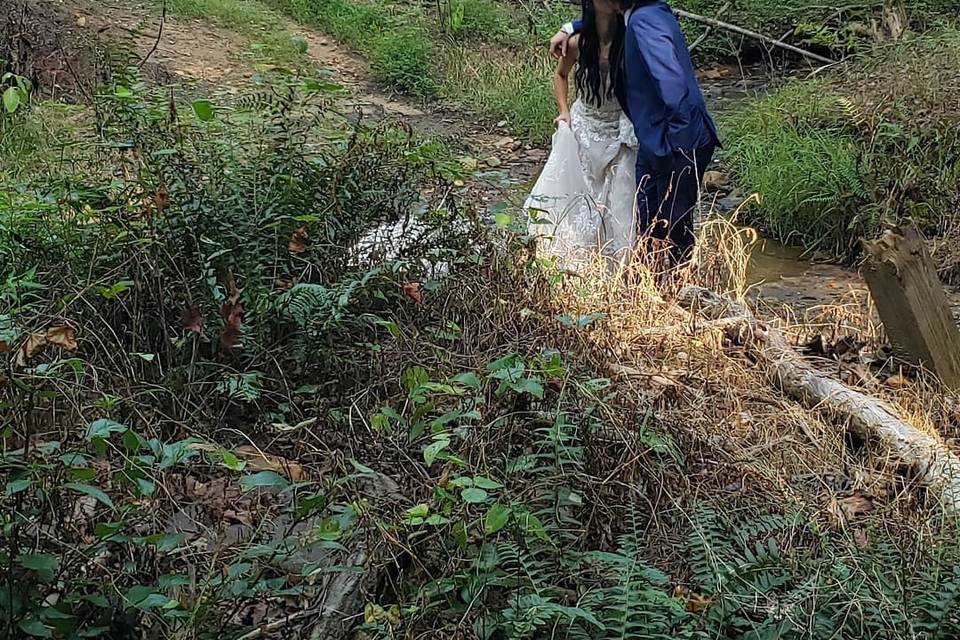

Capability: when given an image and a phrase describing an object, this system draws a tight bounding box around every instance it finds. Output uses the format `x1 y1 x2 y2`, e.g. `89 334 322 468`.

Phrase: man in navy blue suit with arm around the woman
550 0 720 266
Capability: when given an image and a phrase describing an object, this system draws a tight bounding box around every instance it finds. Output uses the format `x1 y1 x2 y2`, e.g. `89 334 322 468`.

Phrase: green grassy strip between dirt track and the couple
258 0 570 140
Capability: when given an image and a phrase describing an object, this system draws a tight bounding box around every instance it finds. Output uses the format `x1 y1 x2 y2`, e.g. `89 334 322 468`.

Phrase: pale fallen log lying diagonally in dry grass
679 287 960 512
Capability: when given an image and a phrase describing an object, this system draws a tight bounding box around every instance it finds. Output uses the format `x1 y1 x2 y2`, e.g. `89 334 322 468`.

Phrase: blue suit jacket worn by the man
574 0 719 173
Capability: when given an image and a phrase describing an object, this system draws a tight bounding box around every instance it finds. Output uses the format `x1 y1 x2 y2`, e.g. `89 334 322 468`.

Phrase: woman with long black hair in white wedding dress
526 0 637 268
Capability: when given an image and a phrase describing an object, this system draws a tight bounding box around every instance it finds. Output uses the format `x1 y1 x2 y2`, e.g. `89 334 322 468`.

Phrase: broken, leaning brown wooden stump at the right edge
863 225 960 389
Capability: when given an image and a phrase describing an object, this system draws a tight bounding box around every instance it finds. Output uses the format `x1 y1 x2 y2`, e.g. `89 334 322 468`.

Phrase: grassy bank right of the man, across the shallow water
723 29 960 278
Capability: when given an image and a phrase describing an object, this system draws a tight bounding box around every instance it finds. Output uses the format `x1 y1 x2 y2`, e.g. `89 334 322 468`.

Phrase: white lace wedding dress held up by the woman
526 98 637 270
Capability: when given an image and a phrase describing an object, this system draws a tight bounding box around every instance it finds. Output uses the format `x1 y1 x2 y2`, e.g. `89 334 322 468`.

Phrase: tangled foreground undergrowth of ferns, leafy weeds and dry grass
0 35 960 640
